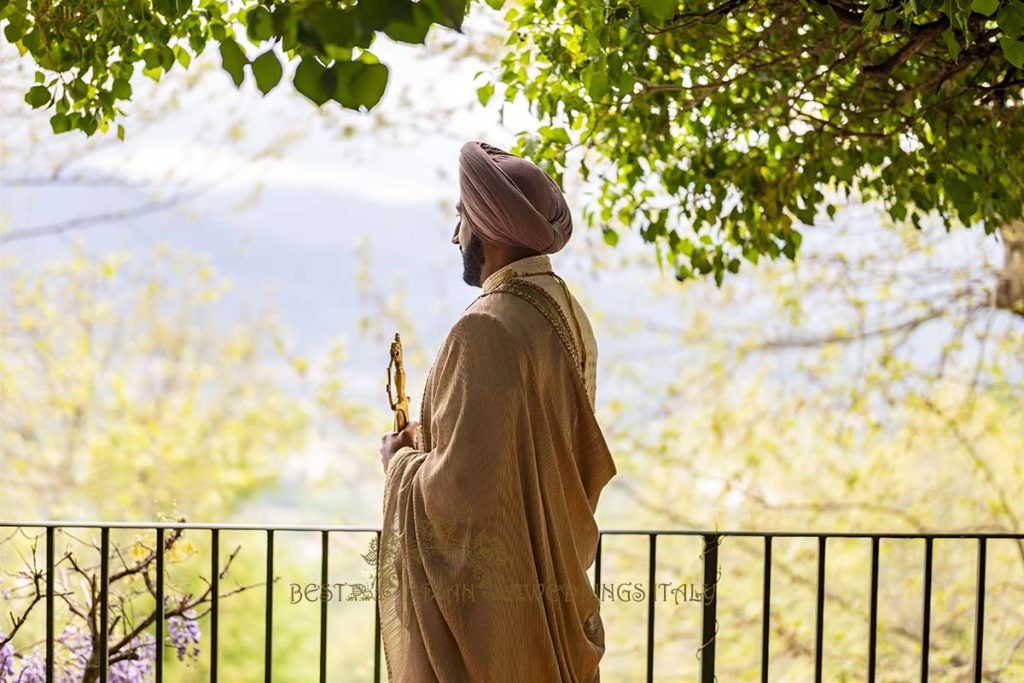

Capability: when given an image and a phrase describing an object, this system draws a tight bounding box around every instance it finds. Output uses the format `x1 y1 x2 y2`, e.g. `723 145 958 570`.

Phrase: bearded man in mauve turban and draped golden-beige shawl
377 141 615 683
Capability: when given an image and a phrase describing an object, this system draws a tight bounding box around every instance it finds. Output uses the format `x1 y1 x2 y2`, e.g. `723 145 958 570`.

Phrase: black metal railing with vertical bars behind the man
0 521 1024 683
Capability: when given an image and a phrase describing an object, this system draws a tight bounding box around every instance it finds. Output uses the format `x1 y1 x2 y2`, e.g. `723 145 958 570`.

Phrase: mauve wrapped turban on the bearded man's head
459 140 572 254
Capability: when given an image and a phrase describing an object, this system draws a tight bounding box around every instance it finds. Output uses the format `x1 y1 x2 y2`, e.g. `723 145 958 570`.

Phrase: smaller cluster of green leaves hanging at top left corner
0 0 466 138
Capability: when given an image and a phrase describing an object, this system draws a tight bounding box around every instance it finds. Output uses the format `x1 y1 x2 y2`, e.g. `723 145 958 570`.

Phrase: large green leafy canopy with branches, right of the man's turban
487 0 1024 283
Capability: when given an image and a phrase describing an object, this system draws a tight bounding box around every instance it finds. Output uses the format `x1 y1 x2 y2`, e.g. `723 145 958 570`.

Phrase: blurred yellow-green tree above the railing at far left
0 247 307 519
